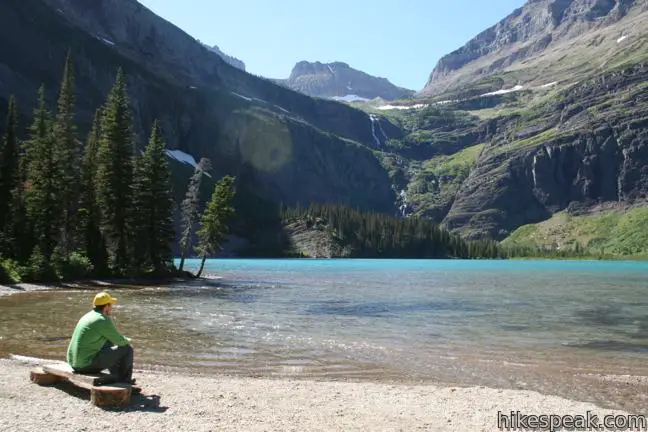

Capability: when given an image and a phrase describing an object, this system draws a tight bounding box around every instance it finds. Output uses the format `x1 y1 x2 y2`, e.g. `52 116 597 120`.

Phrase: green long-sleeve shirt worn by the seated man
67 310 130 368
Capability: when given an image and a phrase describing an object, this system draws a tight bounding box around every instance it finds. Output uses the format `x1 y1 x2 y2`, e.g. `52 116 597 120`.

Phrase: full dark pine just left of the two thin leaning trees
133 121 175 273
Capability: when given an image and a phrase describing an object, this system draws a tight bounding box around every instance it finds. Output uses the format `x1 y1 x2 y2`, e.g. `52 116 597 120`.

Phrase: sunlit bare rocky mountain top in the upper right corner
422 0 648 95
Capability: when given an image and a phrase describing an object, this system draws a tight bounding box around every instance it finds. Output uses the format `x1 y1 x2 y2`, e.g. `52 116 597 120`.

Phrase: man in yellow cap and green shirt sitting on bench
67 292 135 384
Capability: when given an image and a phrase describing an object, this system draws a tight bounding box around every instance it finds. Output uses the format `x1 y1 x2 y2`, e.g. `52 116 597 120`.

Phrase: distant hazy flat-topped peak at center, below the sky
278 61 414 102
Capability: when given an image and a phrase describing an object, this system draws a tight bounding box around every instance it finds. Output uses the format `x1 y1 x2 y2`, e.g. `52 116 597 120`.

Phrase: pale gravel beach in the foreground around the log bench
0 359 636 432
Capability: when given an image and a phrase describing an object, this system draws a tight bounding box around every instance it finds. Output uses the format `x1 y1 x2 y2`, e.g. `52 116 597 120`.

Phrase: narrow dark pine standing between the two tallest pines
79 110 108 275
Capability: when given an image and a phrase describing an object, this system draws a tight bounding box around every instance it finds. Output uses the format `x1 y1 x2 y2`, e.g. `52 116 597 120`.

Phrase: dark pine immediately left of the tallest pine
25 86 61 260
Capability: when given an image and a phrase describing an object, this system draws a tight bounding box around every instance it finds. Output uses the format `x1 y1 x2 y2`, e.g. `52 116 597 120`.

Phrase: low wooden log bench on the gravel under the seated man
30 363 137 406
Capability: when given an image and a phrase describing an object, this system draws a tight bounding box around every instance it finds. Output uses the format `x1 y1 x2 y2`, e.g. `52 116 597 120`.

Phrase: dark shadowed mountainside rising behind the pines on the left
0 0 400 215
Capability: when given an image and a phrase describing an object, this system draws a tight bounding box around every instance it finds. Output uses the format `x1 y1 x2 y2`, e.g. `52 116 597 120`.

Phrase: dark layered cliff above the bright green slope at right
430 64 648 239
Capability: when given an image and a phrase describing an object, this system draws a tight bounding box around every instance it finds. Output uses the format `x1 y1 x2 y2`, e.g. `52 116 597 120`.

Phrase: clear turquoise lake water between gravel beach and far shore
0 260 648 412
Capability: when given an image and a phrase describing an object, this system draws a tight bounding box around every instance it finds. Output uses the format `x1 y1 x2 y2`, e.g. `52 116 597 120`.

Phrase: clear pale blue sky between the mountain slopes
140 0 524 90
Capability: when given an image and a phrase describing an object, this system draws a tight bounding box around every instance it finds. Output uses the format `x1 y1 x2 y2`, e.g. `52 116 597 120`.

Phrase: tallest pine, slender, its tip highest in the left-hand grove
53 53 82 259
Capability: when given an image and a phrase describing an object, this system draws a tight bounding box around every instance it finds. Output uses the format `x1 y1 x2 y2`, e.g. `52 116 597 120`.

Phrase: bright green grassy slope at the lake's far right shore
502 207 648 256
